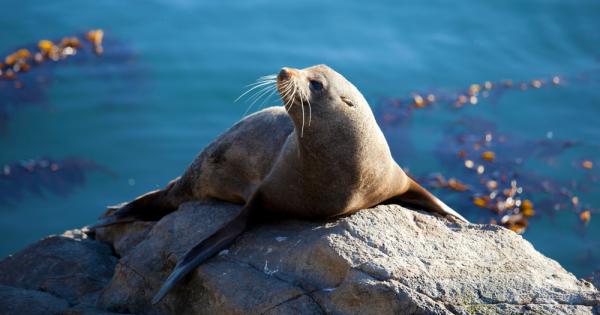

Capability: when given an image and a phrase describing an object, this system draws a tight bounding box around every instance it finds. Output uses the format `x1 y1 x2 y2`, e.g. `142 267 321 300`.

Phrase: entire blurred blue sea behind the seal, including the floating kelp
0 0 600 277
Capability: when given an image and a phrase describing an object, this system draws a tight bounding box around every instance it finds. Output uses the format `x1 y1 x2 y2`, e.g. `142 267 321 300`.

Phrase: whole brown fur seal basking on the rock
94 65 467 303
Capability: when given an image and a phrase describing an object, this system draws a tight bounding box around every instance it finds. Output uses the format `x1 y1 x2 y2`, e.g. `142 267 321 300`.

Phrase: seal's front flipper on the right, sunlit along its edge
386 178 469 223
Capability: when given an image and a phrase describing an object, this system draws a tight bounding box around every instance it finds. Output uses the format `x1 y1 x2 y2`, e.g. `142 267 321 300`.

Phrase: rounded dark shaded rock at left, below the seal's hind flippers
0 230 117 304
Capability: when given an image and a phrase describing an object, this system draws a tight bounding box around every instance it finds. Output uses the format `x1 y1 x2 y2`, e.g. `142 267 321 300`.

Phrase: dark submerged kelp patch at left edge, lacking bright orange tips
0 158 103 206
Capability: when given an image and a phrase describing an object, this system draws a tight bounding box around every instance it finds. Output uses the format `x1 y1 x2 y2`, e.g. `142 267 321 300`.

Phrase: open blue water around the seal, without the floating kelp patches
0 0 600 276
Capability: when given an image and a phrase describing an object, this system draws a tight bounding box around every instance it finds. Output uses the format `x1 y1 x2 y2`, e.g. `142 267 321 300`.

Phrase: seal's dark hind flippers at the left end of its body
90 179 179 230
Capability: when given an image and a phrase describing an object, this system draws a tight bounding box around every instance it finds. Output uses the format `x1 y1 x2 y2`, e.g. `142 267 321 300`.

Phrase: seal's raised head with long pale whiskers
277 65 373 135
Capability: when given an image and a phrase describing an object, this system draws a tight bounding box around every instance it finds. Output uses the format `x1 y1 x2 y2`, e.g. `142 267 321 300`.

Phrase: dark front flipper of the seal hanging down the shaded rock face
152 206 250 304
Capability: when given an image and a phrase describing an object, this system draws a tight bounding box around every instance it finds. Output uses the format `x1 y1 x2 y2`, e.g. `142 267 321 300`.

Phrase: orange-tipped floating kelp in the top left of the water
0 30 144 127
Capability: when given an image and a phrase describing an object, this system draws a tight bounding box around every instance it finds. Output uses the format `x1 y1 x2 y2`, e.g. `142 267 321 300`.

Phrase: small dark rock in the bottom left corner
0 285 69 315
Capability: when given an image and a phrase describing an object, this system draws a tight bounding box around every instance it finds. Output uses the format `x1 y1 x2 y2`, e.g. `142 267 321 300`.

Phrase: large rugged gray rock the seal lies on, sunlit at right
0 203 600 314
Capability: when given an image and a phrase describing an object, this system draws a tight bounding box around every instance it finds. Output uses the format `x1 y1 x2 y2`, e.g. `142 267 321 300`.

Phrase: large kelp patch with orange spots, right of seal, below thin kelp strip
412 118 597 233
